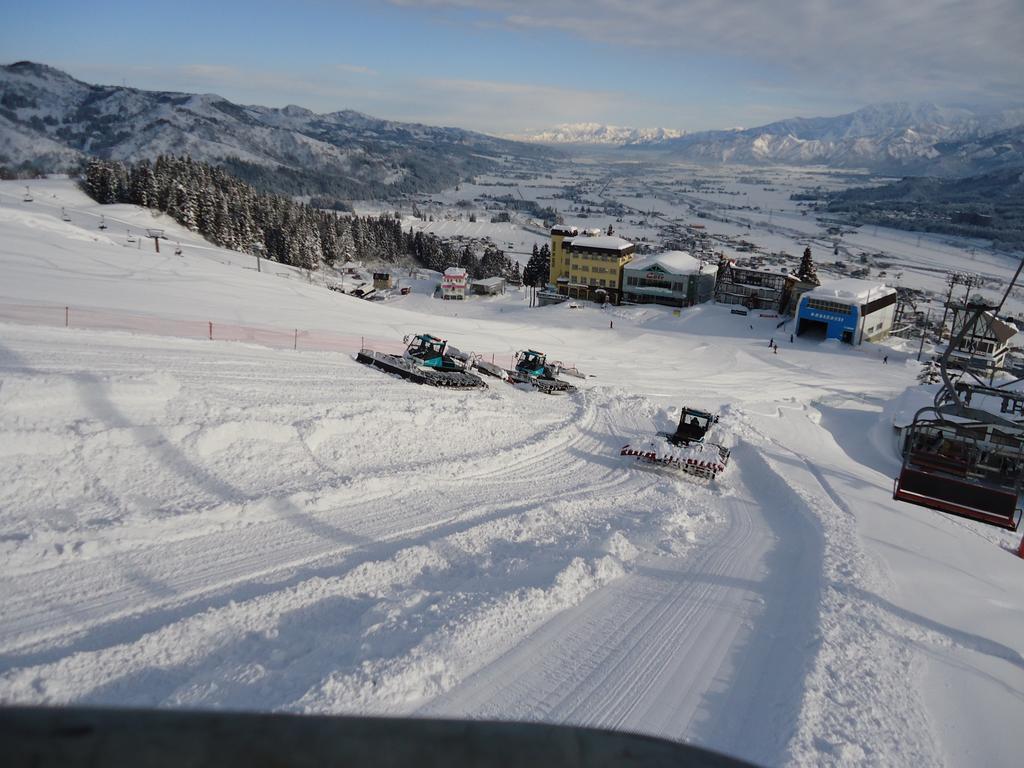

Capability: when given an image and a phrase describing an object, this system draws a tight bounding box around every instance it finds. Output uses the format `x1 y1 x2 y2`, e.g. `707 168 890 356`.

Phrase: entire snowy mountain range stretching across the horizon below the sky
0 61 1024 189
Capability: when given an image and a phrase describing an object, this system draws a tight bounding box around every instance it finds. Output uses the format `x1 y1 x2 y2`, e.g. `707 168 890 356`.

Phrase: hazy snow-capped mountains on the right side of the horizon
636 103 1024 175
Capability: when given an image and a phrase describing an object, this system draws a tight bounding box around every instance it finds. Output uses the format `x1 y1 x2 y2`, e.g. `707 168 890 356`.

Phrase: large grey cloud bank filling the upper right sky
392 0 1024 101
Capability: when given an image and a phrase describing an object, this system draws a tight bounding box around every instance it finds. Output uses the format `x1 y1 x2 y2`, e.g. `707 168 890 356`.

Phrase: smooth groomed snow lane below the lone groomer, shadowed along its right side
420 445 821 765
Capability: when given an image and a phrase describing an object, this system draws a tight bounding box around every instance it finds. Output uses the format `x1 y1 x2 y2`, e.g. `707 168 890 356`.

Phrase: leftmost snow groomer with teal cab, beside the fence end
355 334 487 389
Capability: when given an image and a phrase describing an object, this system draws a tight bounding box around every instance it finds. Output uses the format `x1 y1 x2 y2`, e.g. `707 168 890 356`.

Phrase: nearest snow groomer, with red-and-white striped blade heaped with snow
621 408 729 480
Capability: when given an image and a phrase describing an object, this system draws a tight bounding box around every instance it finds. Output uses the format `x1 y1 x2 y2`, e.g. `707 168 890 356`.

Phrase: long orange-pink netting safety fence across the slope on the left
0 302 520 366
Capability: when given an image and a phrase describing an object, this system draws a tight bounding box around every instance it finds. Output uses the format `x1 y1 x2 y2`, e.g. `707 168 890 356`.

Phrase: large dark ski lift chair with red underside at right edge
893 407 1024 530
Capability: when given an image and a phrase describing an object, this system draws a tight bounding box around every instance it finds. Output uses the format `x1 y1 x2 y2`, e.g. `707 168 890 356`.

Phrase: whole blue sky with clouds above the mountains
0 0 1024 134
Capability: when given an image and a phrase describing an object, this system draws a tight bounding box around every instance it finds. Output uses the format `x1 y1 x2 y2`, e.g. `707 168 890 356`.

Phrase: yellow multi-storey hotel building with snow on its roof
549 224 636 304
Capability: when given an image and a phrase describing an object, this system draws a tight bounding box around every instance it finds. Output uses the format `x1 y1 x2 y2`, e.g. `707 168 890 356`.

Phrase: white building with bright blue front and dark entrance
797 278 896 344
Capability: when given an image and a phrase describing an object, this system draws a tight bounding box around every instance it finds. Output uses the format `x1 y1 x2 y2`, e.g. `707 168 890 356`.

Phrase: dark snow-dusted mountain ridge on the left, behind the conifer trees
0 61 551 197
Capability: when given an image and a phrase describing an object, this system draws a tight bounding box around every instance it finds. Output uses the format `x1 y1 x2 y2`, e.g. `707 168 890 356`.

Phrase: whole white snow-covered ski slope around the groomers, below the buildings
0 180 1024 766
